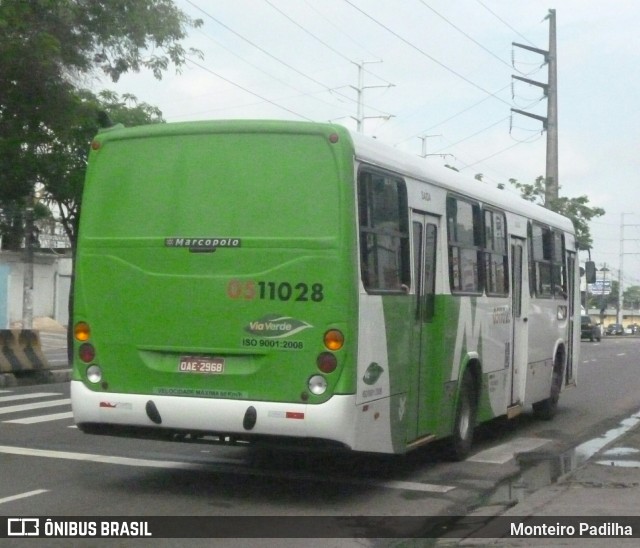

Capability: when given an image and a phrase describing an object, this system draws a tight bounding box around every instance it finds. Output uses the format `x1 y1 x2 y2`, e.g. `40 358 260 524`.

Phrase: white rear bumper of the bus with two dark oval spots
71 381 356 449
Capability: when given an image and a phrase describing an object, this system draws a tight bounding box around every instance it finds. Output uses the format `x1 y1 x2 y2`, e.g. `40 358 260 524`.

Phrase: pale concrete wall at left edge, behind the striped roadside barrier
0 251 72 329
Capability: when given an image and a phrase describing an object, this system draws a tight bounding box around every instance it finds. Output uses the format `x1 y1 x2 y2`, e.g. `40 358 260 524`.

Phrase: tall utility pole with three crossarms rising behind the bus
511 9 560 207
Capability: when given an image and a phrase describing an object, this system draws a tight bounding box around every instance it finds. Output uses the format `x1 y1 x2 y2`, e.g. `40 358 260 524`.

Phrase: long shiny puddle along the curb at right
479 411 640 507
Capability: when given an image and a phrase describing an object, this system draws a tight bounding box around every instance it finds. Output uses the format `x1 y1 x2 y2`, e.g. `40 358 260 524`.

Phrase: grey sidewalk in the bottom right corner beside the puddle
450 415 640 548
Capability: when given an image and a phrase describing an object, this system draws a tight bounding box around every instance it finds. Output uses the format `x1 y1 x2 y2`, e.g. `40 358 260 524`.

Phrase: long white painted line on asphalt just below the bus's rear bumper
0 445 455 493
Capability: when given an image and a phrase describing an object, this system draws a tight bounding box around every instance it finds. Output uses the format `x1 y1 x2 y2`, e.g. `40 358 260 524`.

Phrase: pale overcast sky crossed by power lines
101 0 640 296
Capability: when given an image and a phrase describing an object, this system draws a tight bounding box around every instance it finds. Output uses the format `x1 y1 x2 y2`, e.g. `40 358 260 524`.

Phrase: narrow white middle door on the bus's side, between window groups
509 236 529 407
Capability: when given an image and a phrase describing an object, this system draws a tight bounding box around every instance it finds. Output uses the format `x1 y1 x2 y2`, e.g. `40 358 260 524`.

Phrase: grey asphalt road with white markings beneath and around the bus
0 337 640 546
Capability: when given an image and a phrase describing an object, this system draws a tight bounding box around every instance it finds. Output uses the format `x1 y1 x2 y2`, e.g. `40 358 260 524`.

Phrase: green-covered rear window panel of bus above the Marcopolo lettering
83 134 341 239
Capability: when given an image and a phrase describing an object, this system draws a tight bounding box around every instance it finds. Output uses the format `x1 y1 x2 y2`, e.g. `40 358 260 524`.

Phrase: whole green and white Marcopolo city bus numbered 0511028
71 120 580 458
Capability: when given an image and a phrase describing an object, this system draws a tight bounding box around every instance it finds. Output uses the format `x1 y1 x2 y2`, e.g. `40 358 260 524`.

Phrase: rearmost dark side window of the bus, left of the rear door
358 170 411 293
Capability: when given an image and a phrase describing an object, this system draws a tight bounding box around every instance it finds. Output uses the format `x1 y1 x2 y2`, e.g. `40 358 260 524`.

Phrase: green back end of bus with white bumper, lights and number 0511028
71 121 358 447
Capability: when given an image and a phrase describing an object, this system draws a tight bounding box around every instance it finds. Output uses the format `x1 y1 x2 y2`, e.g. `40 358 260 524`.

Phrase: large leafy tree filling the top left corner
0 0 202 248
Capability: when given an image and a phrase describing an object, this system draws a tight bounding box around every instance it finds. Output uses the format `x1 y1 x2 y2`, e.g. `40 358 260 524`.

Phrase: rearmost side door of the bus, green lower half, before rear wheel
407 211 439 442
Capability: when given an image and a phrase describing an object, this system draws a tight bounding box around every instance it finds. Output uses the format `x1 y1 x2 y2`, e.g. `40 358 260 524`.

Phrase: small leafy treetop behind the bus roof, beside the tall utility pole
509 175 605 249
